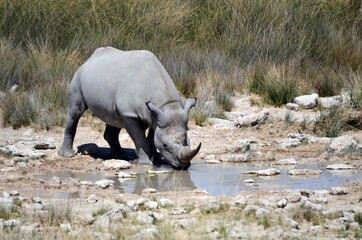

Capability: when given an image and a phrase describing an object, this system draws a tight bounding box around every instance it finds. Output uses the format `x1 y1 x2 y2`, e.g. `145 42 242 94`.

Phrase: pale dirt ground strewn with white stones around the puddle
0 96 362 239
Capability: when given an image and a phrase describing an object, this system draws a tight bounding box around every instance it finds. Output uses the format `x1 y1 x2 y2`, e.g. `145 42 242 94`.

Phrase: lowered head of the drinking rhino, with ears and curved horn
146 98 201 169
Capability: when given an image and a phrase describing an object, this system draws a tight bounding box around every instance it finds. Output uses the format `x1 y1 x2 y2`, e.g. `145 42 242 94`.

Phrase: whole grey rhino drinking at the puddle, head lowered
58 47 201 169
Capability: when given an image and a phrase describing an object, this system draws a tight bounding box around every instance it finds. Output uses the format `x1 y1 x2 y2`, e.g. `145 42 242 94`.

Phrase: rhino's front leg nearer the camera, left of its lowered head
125 118 152 164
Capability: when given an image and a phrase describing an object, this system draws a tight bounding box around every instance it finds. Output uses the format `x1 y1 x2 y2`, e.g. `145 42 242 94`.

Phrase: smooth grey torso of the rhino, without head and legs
79 47 181 127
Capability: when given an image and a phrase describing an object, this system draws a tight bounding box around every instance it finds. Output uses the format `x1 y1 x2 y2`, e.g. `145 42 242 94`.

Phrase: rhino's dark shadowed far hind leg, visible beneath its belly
103 124 129 160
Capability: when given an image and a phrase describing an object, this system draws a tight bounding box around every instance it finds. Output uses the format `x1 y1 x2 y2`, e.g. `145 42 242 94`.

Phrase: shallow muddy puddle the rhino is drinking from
40 162 362 198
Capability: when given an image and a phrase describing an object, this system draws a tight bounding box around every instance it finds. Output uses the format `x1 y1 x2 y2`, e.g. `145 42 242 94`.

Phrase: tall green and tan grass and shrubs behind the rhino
0 0 362 129
